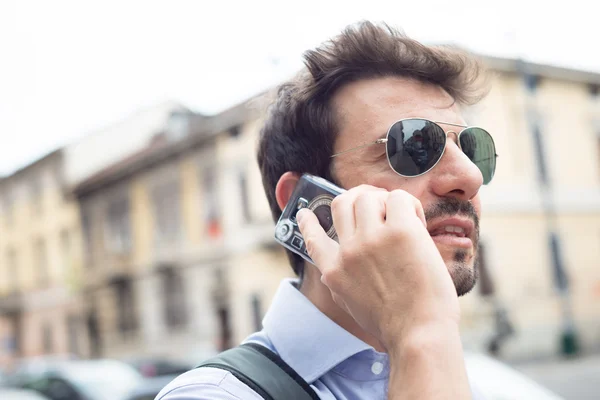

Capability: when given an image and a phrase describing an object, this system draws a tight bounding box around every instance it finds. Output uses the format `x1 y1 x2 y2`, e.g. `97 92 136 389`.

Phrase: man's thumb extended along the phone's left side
296 208 339 273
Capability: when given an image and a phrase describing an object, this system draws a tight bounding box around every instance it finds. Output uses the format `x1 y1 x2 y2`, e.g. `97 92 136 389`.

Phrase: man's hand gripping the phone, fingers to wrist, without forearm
298 185 459 349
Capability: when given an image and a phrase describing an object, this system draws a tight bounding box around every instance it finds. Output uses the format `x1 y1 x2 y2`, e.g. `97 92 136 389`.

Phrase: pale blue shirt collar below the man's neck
263 279 373 383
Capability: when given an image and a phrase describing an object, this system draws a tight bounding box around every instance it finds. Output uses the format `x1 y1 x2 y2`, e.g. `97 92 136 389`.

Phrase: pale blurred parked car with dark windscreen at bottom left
15 360 143 400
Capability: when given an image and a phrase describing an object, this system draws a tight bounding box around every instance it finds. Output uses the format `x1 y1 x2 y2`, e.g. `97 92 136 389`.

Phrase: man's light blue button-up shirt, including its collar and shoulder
155 279 481 400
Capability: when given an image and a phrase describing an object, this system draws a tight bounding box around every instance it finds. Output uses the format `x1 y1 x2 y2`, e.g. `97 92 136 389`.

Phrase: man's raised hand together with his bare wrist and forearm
297 185 469 399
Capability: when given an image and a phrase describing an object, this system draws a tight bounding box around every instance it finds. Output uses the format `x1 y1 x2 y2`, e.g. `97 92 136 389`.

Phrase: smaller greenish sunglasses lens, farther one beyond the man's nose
460 128 496 185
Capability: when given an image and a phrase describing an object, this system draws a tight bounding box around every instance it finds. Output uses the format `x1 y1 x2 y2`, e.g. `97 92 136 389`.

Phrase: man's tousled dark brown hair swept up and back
258 22 487 277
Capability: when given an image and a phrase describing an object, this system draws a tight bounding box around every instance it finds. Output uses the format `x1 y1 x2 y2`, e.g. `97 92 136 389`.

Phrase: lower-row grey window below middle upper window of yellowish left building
161 267 187 328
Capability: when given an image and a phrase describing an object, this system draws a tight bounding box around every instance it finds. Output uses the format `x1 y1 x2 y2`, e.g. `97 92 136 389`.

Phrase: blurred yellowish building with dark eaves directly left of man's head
75 99 291 362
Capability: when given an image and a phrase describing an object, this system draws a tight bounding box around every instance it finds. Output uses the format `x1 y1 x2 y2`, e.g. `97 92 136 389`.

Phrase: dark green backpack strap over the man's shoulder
196 343 319 400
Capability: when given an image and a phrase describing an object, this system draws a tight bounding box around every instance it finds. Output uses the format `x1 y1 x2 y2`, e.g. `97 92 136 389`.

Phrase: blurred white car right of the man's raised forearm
465 353 563 400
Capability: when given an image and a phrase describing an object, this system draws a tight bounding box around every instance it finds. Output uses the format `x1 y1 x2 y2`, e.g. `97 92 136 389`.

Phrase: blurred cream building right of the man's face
462 58 600 358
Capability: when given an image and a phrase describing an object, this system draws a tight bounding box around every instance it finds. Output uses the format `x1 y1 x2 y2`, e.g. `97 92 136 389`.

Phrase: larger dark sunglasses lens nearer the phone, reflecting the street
387 118 446 176
